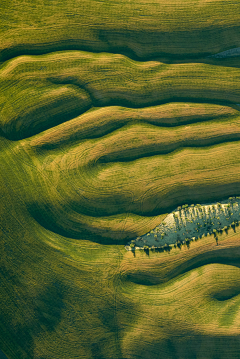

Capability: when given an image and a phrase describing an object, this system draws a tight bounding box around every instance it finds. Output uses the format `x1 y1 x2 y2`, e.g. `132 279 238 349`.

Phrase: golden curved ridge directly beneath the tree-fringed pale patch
121 227 240 286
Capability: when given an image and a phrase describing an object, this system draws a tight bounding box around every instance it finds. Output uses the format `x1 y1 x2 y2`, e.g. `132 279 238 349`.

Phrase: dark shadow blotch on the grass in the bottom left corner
0 270 64 359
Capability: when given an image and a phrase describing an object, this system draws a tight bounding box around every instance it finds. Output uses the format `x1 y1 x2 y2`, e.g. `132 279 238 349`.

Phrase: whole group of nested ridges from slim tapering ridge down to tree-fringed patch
13 100 239 243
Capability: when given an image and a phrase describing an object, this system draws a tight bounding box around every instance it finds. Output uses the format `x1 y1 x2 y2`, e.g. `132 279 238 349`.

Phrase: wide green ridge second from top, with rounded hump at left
0 51 240 140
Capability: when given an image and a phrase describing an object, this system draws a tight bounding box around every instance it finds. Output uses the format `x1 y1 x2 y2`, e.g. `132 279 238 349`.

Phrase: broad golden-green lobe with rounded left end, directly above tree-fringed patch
9 138 239 241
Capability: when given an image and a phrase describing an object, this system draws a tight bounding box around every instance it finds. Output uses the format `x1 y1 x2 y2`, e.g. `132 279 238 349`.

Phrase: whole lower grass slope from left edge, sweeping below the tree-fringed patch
0 146 240 359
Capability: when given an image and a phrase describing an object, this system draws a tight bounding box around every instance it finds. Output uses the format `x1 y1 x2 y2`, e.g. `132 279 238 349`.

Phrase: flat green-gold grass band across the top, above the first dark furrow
0 0 240 60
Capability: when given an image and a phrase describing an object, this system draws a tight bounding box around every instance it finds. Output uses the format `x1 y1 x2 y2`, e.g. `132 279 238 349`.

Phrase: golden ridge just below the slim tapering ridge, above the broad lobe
66 116 240 163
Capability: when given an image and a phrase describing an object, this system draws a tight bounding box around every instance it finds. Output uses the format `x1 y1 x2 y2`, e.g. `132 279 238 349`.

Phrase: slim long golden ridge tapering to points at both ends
30 102 239 152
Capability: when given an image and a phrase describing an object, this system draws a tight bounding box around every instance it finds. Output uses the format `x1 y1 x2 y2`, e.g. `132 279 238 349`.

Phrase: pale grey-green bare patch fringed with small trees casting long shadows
125 197 240 250
